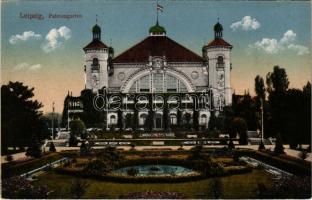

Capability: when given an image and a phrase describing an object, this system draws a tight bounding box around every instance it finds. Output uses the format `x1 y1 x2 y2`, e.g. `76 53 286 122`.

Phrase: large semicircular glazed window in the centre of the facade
130 73 187 93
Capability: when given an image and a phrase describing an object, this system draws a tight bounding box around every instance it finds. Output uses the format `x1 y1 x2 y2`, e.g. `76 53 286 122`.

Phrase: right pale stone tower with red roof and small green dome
203 22 232 106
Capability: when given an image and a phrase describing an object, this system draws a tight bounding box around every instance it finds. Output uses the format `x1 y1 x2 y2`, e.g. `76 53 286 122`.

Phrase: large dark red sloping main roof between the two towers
113 36 203 63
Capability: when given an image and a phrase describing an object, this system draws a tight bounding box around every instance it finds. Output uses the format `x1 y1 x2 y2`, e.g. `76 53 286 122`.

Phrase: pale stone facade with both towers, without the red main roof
84 23 232 127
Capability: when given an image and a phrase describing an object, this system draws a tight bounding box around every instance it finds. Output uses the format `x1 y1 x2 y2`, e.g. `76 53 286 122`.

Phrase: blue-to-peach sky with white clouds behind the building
1 0 312 112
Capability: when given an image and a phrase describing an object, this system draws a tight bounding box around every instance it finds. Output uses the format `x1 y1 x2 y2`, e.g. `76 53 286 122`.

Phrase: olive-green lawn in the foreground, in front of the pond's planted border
35 169 272 199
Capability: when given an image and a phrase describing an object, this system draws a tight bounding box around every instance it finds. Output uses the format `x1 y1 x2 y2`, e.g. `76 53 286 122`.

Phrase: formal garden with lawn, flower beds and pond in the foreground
3 146 311 199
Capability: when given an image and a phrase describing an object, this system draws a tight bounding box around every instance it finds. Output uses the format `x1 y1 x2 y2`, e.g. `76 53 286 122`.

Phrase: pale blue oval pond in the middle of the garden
113 165 198 176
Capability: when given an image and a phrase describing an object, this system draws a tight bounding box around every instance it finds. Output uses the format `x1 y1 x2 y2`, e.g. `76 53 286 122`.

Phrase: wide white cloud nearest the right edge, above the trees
249 30 310 55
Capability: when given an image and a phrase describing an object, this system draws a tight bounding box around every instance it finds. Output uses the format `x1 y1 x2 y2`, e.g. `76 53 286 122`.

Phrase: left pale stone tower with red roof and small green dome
83 24 109 93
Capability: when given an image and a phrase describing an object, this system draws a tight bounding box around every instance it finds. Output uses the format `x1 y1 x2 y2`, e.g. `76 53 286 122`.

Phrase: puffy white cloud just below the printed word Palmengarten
42 26 71 53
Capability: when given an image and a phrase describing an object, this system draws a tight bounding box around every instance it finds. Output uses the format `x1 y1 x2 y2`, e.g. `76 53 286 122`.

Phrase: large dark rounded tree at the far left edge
1 81 50 153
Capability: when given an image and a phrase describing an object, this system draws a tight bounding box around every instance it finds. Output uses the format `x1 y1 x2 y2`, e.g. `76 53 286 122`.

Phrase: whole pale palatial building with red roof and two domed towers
67 20 232 130
